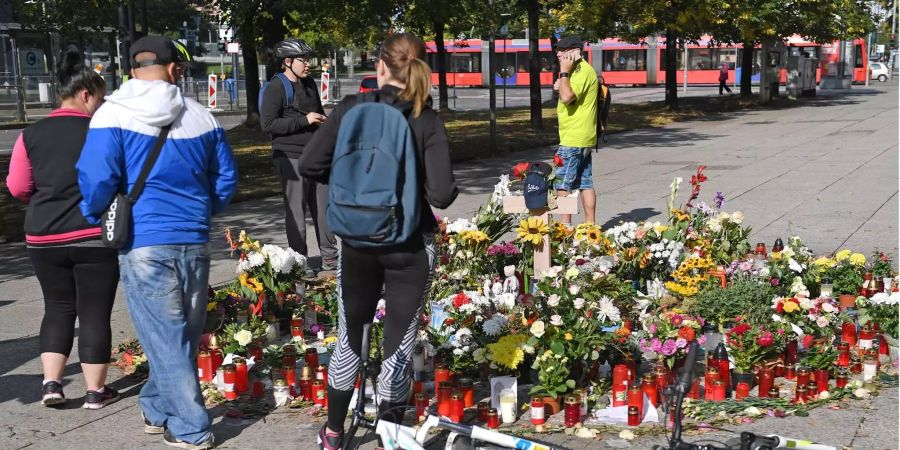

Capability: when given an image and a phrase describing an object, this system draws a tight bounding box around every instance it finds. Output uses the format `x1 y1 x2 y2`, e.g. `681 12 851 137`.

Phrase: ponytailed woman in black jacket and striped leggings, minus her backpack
300 33 458 450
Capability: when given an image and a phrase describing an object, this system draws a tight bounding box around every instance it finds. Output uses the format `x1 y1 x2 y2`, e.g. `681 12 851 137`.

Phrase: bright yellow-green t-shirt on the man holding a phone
556 58 598 147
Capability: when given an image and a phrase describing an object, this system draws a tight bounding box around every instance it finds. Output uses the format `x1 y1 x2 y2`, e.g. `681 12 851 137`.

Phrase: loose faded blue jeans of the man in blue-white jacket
119 244 210 444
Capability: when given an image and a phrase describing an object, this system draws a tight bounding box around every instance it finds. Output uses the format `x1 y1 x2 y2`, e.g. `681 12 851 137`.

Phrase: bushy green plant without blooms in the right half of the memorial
688 279 773 325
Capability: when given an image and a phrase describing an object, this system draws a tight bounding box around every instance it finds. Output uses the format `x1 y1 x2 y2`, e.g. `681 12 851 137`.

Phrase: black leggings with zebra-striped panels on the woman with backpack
328 235 435 431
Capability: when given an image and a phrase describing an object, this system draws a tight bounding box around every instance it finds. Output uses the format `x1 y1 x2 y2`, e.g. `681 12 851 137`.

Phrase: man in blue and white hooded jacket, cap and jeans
76 36 237 449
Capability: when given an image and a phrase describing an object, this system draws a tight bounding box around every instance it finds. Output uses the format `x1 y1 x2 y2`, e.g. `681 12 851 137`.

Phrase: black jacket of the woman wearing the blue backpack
300 85 459 232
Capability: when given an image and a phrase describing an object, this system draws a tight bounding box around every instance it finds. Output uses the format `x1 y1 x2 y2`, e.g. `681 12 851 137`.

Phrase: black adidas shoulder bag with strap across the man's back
100 125 172 249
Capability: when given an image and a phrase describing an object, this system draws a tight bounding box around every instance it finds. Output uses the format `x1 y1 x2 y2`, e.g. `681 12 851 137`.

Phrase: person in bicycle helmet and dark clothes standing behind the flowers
259 39 337 271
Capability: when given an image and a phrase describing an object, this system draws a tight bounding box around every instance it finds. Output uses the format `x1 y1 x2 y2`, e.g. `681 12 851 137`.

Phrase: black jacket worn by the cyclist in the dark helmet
259 77 325 158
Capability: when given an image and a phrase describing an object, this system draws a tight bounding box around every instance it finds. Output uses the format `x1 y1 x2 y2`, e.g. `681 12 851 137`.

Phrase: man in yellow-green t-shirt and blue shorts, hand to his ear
553 36 598 223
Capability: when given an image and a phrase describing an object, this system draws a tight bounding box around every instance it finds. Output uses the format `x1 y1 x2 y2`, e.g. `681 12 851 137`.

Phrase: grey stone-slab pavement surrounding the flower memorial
0 84 898 450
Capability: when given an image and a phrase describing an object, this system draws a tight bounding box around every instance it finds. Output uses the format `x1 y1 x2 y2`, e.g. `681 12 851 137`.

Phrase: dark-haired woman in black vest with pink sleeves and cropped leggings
6 46 119 409
